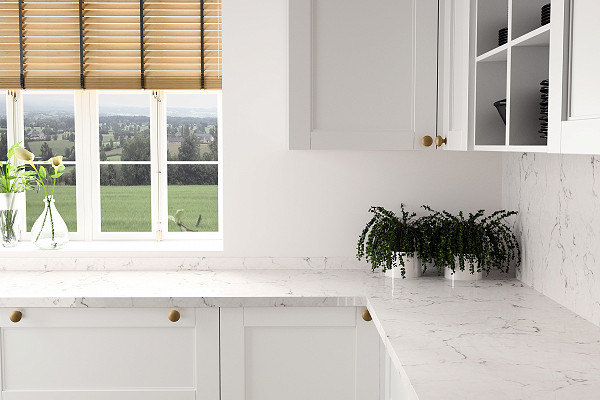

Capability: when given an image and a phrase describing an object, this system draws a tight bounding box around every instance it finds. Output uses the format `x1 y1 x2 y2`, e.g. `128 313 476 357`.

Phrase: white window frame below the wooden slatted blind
0 90 224 248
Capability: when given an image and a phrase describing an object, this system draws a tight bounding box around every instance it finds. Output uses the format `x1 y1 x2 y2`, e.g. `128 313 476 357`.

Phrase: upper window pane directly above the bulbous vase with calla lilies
23 93 75 161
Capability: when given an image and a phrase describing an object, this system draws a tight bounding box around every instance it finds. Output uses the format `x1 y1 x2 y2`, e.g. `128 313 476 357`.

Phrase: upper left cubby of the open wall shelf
477 0 510 56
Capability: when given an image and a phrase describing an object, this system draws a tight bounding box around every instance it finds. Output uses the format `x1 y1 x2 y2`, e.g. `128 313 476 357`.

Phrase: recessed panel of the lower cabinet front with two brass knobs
3 328 195 391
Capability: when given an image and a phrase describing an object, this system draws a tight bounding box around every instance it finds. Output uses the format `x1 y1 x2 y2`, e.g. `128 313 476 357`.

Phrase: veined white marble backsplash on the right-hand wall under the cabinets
502 154 600 326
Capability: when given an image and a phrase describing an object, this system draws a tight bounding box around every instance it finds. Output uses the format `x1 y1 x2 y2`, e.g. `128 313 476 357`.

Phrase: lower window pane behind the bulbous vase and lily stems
26 164 77 232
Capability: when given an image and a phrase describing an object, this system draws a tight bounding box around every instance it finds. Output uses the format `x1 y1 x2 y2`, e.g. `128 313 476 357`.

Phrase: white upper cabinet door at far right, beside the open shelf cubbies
548 0 600 154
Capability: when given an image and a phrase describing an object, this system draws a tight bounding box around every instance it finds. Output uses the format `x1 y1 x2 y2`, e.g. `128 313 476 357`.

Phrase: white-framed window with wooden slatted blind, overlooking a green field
0 0 223 249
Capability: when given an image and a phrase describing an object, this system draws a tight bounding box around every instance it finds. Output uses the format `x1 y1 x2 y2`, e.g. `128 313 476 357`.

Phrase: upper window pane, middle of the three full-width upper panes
98 93 150 161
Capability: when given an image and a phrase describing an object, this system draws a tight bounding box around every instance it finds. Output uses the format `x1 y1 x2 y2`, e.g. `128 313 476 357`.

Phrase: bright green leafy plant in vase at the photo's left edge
0 143 35 247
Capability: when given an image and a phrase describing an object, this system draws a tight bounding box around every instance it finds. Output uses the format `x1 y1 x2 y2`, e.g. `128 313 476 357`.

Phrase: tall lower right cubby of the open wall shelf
508 46 549 146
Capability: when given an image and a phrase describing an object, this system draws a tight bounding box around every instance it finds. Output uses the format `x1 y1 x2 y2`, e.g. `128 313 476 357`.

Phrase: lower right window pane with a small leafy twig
167 165 219 232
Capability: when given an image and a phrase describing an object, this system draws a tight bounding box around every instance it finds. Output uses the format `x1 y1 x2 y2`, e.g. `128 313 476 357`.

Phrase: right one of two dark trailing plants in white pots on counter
415 206 521 280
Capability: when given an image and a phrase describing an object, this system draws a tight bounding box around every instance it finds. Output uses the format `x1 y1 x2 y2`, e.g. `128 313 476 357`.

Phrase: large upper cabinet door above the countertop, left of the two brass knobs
289 0 438 150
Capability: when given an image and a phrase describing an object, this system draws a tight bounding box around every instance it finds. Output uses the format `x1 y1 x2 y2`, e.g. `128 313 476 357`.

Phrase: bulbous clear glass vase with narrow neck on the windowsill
31 199 69 250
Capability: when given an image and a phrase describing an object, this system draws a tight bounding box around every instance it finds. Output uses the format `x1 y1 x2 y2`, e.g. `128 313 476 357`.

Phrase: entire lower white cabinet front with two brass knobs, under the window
0 308 219 400
